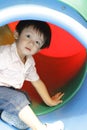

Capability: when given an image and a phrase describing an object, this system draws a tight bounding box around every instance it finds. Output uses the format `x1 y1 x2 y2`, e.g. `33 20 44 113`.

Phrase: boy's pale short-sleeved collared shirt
0 43 39 89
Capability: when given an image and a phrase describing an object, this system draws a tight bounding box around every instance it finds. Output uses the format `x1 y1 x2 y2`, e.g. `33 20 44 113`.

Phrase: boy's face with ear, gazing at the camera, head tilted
15 26 44 56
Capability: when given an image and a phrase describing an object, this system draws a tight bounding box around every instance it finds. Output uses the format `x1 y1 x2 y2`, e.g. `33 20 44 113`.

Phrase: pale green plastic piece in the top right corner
58 0 87 20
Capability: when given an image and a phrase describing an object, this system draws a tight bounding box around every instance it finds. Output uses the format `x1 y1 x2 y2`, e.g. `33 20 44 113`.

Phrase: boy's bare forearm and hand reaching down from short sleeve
31 79 64 106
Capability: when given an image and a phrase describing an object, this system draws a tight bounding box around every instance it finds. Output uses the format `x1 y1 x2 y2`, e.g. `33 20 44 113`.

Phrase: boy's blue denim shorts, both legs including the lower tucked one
0 86 30 129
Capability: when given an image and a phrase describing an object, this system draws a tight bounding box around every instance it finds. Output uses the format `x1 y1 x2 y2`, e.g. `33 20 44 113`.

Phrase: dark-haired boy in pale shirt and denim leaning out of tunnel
0 20 64 130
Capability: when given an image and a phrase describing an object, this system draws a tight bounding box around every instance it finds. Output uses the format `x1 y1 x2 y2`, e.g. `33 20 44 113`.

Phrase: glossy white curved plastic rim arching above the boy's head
0 4 87 48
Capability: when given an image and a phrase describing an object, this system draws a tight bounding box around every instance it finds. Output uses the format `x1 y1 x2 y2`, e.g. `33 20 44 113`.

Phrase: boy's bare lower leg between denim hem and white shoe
18 105 46 130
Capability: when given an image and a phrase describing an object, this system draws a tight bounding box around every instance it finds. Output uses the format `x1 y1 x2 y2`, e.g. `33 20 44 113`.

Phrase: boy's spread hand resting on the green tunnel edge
51 92 64 106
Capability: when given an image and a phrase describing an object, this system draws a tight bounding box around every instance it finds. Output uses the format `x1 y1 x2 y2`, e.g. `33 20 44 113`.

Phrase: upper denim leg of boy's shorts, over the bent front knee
0 86 30 115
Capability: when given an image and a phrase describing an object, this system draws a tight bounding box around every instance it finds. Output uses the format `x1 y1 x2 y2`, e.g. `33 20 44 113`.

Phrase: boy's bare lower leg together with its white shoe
19 105 64 130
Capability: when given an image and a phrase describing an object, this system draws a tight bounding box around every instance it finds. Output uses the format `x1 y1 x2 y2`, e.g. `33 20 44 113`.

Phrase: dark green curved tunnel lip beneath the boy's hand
31 63 86 115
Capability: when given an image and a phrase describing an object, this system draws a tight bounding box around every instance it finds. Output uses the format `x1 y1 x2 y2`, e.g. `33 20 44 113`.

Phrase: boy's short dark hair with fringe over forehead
16 20 51 49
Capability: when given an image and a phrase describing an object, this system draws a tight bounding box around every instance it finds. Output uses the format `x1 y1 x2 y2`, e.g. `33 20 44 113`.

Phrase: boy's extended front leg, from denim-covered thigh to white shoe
0 87 63 130
